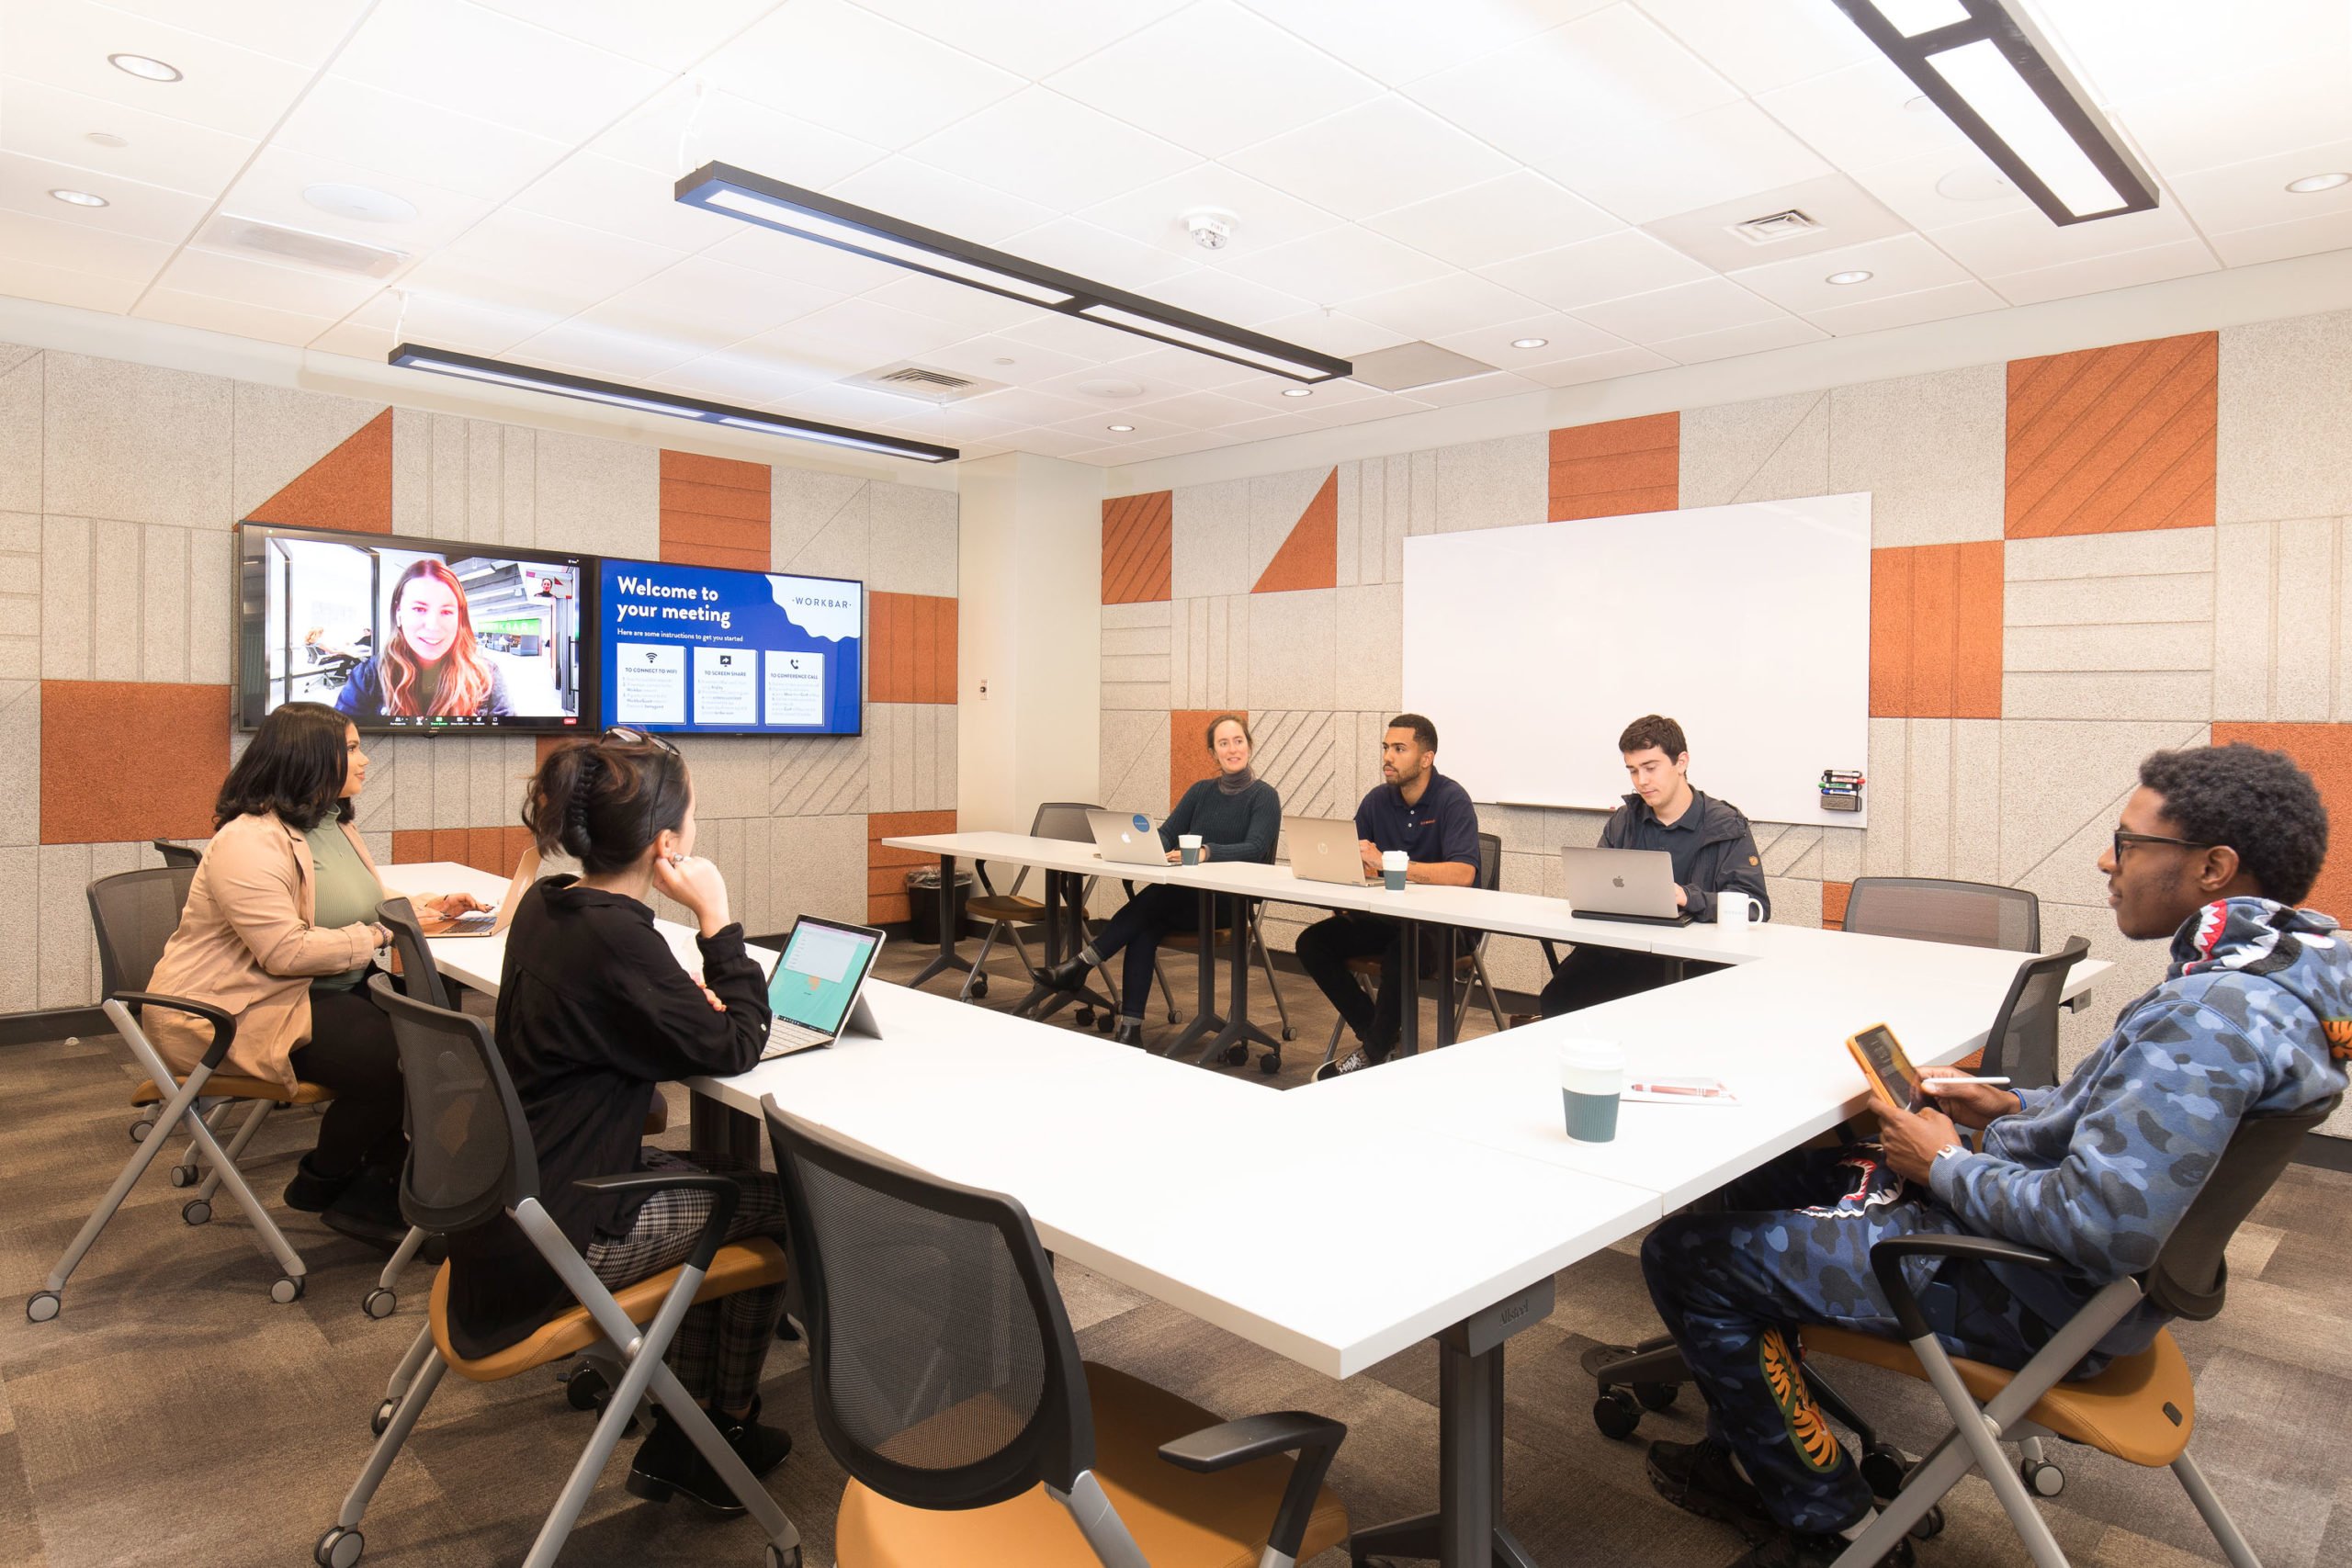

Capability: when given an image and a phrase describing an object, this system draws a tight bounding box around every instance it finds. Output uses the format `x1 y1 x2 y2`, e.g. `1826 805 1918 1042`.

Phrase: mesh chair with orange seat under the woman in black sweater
311 976 799 1568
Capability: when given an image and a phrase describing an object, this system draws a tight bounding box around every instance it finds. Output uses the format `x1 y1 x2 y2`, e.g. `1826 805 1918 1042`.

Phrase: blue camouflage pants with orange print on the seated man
1642 1145 2098 1530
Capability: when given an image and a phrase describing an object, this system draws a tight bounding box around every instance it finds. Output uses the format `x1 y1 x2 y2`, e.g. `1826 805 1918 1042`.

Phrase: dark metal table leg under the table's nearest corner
1348 1277 1553 1568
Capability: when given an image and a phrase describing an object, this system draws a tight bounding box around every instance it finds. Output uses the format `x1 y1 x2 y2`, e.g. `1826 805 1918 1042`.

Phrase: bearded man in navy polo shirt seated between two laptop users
1298 712 1477 1079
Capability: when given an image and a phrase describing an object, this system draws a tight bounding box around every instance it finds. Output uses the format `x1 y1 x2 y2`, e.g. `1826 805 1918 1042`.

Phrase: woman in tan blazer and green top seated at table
146 703 480 1248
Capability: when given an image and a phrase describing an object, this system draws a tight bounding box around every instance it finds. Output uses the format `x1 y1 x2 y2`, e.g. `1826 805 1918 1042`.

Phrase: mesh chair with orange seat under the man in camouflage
1804 1098 2338 1568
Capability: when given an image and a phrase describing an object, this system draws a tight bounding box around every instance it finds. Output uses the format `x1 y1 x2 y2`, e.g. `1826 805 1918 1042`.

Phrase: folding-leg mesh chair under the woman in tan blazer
24 865 332 1324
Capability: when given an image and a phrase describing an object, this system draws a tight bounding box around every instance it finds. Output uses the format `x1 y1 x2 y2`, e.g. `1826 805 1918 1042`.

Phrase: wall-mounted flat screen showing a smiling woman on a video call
238 522 595 736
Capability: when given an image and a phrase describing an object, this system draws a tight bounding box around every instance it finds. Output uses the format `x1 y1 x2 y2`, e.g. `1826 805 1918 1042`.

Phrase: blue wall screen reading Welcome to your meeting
597 559 865 736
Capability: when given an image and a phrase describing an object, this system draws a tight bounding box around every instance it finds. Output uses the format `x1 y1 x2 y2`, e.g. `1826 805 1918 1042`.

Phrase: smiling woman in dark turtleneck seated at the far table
1045 712 1282 1046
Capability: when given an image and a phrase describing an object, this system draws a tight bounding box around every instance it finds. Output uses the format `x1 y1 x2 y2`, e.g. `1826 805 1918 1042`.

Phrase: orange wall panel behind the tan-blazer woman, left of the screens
40 682 228 844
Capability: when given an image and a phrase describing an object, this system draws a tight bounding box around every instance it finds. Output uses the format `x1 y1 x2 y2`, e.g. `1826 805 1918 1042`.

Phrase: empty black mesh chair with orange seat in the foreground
762 1098 1348 1568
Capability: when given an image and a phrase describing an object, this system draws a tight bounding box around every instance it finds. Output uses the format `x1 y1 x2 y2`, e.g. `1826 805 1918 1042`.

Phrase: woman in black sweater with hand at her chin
449 728 793 1514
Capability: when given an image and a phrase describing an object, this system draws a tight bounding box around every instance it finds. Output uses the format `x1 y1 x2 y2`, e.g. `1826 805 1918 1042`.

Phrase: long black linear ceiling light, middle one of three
677 163 1350 383
